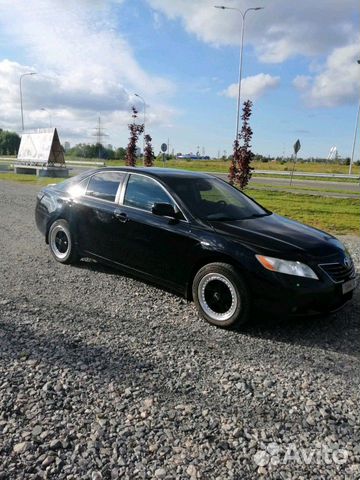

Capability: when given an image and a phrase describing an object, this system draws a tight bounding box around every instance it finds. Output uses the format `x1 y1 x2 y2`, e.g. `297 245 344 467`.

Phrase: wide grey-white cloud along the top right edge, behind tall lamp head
148 0 358 63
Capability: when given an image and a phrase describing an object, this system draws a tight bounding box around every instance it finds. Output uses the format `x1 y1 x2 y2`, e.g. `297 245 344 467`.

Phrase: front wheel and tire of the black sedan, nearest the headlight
192 263 250 328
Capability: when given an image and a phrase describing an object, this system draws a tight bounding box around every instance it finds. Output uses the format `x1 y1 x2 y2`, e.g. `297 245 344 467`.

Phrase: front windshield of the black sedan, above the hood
166 177 269 221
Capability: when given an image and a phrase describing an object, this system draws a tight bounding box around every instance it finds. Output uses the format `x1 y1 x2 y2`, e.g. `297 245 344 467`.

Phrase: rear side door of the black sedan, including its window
72 171 126 258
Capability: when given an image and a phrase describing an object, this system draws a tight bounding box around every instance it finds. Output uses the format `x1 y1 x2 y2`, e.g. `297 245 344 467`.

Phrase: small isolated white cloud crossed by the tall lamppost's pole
222 73 280 100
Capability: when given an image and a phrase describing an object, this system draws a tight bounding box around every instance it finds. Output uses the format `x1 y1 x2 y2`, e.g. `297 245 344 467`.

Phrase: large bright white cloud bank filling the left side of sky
0 0 175 142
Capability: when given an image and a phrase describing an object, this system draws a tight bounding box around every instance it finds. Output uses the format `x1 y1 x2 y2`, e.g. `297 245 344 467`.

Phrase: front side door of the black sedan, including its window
107 173 198 285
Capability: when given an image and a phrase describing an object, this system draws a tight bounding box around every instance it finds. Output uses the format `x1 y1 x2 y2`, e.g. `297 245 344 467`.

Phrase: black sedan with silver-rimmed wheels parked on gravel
36 168 356 327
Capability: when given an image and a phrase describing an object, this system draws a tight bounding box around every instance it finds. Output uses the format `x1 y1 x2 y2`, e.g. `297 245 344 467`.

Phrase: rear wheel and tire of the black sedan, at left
49 220 80 264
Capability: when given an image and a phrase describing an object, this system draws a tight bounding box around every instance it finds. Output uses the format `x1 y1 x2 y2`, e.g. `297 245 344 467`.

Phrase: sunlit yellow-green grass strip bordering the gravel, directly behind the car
0 172 360 235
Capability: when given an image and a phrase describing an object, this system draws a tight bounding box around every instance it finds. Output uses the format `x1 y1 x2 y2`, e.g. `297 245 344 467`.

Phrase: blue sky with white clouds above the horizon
0 0 360 159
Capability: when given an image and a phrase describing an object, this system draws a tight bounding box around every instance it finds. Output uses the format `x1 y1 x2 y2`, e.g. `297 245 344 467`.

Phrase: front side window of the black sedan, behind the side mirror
124 175 175 212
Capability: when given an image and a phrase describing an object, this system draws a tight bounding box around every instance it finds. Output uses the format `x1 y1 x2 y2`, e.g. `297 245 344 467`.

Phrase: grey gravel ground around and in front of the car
0 182 360 480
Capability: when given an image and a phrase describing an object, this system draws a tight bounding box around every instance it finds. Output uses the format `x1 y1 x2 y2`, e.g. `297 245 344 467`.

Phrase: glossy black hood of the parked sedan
211 213 344 257
